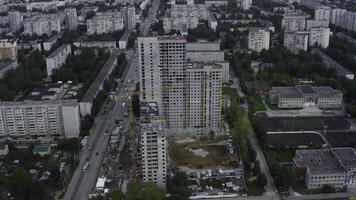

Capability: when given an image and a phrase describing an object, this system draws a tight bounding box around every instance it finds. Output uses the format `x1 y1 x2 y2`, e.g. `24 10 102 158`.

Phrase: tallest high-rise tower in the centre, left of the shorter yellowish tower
138 37 221 134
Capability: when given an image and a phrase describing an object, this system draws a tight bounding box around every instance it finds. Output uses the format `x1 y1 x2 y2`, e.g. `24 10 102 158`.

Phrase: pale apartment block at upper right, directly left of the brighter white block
283 31 309 54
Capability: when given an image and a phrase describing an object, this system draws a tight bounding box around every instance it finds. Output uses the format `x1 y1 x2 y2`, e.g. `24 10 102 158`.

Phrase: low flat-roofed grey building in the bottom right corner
293 147 356 189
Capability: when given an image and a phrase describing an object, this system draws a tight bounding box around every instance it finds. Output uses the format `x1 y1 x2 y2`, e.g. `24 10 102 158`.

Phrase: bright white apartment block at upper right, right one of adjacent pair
309 27 330 48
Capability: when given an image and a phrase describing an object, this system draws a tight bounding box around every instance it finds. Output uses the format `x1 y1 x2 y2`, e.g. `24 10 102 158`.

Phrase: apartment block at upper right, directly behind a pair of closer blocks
282 15 306 32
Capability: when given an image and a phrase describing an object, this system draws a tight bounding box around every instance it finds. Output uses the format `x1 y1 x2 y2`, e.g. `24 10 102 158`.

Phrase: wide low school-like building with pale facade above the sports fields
269 85 343 109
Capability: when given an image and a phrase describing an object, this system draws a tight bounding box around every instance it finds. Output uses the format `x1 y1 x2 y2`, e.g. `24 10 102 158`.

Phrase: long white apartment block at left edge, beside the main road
0 100 80 138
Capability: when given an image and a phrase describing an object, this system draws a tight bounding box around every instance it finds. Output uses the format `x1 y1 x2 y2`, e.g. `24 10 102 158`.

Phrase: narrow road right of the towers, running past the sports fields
230 75 281 200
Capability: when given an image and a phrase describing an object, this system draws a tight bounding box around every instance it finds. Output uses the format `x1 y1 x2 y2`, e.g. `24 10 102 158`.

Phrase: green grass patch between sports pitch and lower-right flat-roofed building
264 148 294 166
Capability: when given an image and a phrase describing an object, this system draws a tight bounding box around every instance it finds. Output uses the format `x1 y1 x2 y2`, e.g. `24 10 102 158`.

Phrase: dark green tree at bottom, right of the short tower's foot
168 171 191 200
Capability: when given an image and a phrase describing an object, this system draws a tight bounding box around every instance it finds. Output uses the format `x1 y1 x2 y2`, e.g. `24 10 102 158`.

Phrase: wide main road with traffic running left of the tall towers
64 0 159 200
